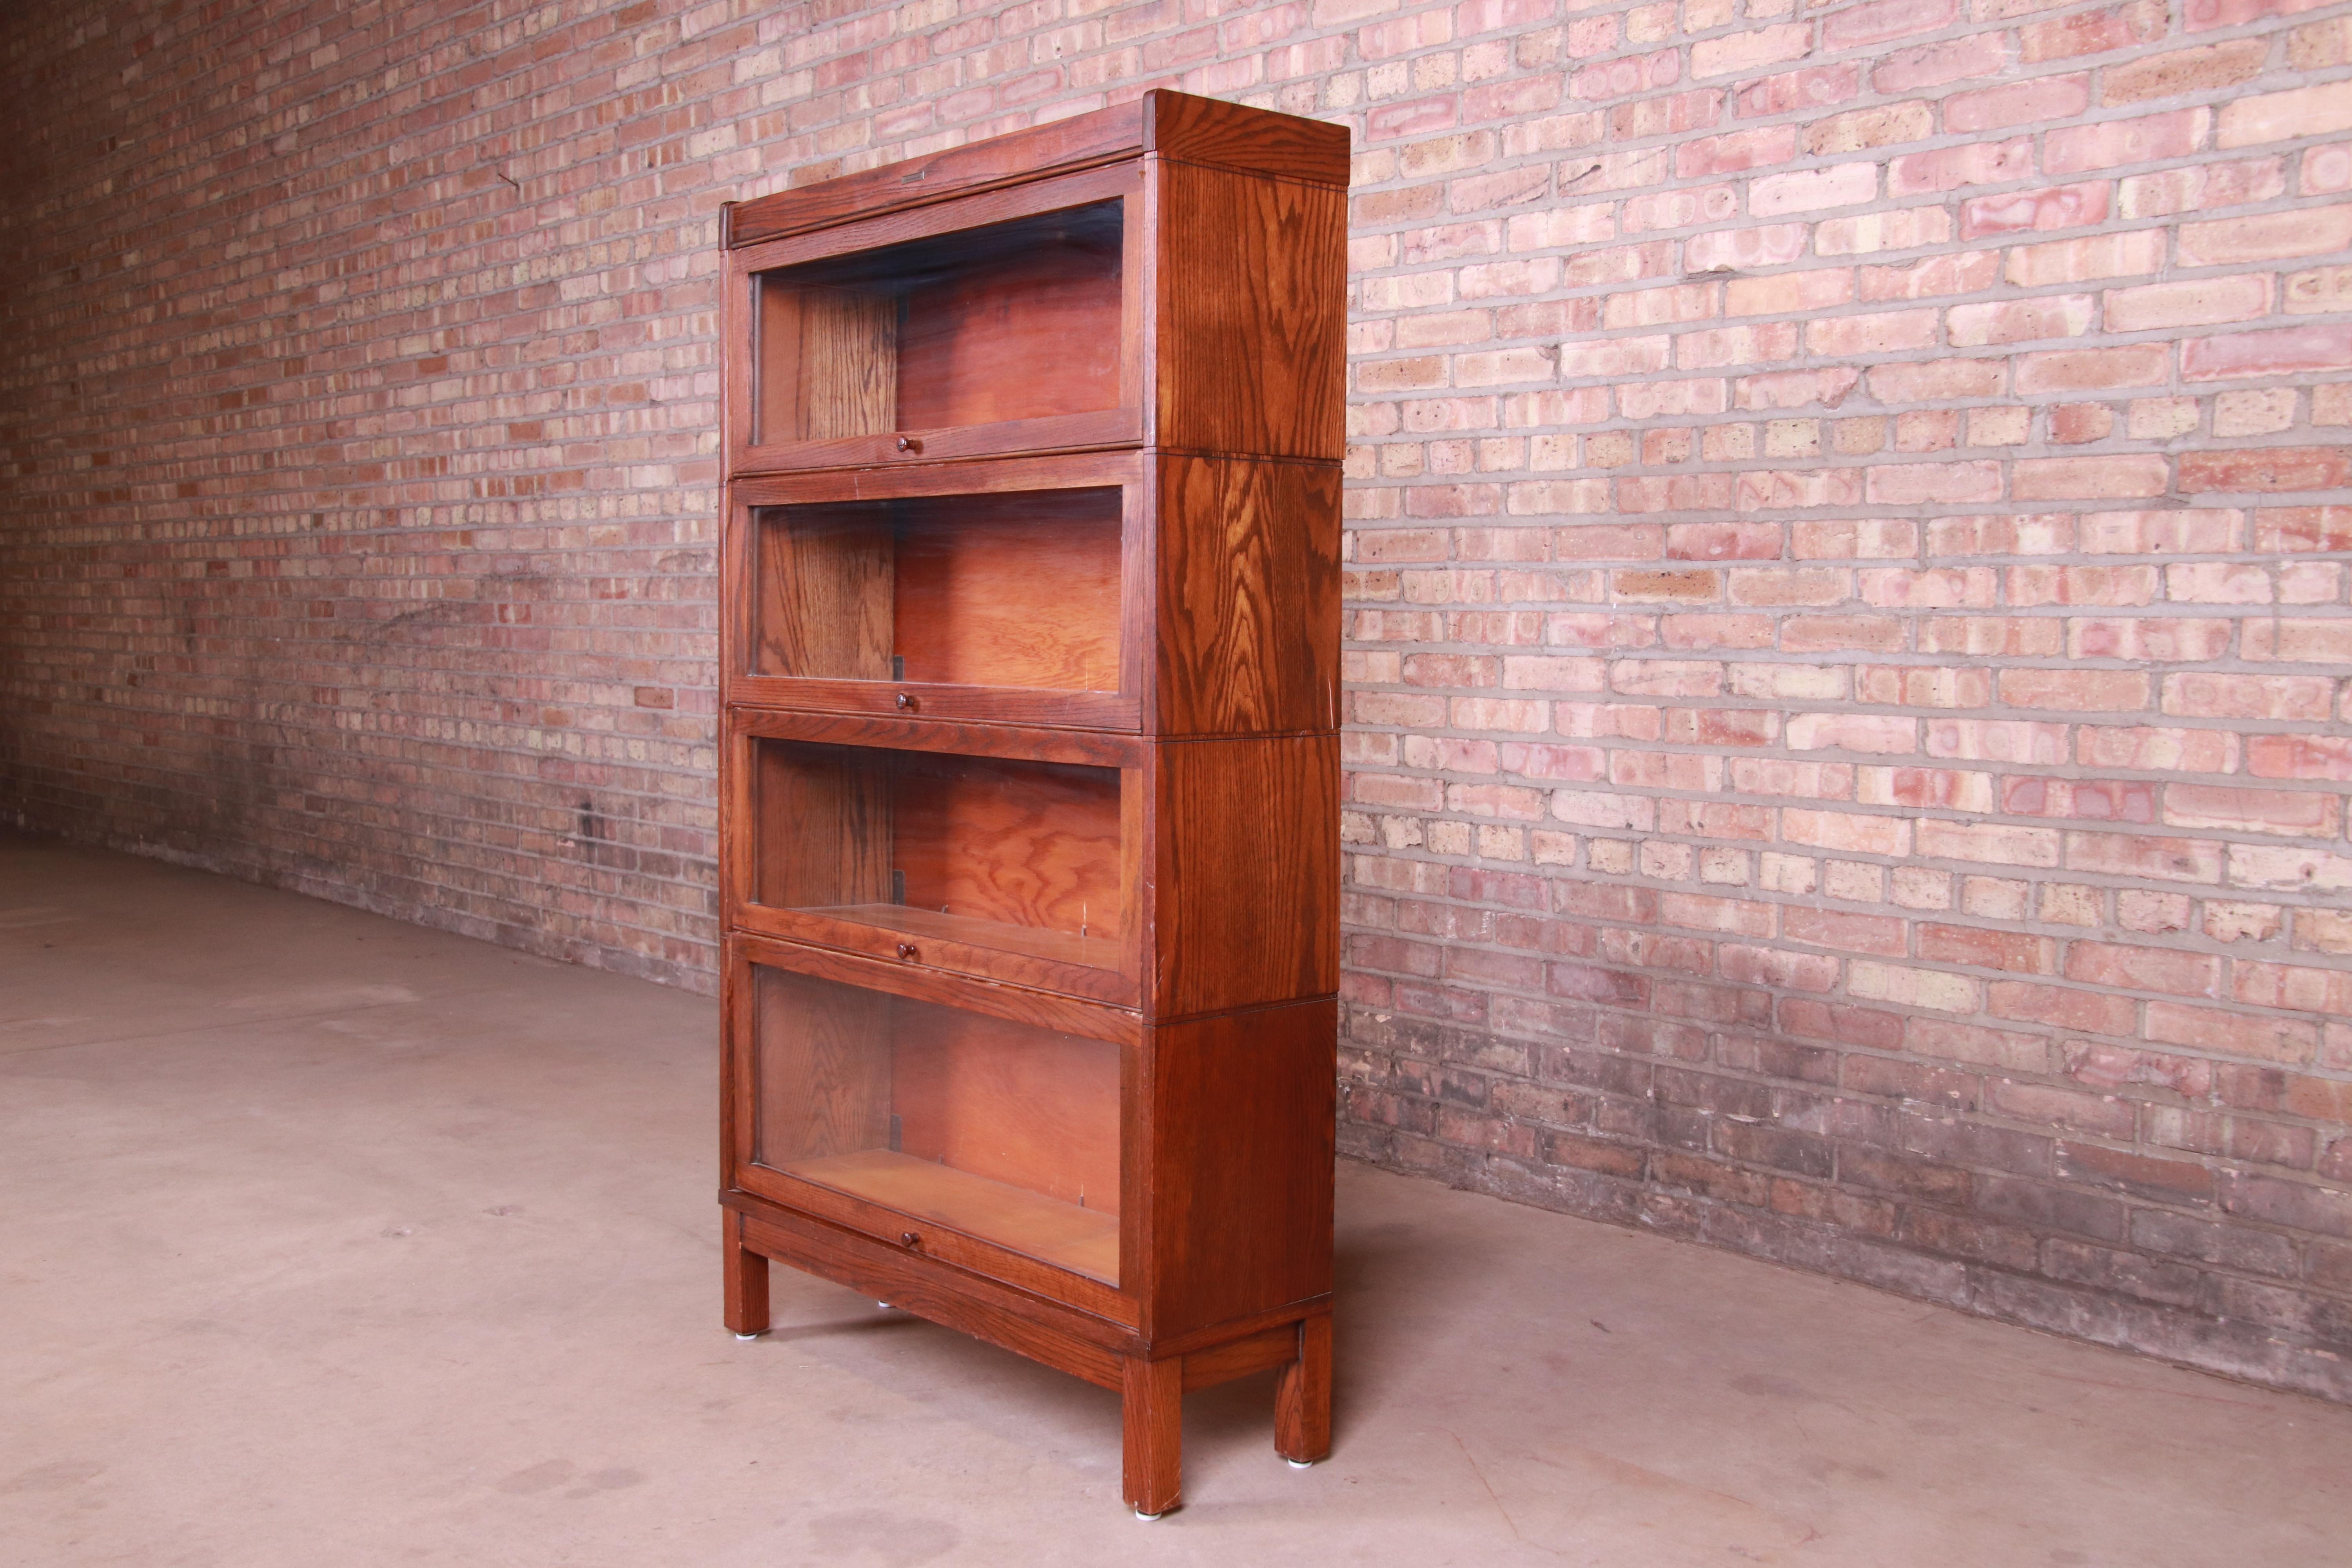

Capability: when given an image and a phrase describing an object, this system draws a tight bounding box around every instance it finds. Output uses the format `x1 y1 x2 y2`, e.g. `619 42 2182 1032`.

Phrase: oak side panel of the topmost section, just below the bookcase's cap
1157 162 1348 463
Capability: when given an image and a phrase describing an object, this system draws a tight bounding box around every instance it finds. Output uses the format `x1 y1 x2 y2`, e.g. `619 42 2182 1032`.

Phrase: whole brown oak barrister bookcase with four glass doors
720 92 1348 1516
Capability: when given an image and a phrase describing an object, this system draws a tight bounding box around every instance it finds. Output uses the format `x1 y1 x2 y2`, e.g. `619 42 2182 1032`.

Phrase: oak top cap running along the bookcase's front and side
727 92 1348 249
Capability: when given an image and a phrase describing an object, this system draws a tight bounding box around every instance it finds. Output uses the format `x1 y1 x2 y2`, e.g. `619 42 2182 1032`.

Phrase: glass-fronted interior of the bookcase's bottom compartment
750 966 1122 1283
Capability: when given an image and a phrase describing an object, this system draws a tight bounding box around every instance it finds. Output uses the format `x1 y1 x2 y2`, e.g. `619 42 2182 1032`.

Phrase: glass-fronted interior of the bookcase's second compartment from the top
748 486 1124 691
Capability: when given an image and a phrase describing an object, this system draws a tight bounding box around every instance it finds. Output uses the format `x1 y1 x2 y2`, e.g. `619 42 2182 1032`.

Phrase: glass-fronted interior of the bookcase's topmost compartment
755 200 1124 444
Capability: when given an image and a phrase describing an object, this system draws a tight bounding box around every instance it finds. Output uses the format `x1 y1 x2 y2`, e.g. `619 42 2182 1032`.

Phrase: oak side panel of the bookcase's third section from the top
1150 736 1338 1018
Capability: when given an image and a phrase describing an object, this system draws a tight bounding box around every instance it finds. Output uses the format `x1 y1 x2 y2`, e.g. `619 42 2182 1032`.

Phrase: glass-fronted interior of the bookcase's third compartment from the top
753 740 1129 969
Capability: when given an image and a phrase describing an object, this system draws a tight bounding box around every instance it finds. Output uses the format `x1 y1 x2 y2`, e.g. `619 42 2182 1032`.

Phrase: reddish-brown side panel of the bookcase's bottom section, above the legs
1143 1002 1338 1342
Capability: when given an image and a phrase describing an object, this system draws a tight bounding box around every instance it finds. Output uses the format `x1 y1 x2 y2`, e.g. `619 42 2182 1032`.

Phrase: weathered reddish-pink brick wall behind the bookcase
0 0 2352 1399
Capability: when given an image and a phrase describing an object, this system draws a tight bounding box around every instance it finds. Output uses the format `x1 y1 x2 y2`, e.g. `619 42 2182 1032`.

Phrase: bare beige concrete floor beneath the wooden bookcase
0 837 2352 1568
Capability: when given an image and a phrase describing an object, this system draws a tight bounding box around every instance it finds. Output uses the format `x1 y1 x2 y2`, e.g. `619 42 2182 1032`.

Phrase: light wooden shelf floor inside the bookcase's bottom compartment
776 1150 1120 1286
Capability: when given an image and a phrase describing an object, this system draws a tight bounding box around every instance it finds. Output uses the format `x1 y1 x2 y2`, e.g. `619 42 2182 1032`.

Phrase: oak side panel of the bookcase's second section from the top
1155 456 1341 736
